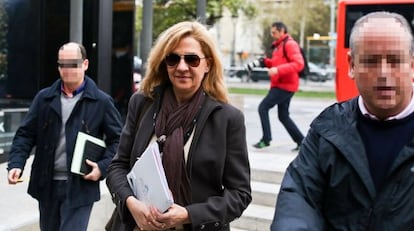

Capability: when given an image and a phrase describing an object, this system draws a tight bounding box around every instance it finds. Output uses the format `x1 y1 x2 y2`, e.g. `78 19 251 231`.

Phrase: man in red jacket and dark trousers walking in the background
253 22 304 151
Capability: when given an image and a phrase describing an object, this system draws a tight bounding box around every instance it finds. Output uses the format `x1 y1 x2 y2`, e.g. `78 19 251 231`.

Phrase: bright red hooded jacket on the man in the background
264 34 304 92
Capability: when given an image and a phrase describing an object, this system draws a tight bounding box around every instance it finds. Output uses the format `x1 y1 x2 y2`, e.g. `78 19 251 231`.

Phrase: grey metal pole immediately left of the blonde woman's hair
140 0 153 77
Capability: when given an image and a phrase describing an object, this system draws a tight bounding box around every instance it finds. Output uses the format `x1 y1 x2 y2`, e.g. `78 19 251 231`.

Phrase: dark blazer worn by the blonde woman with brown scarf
107 89 251 230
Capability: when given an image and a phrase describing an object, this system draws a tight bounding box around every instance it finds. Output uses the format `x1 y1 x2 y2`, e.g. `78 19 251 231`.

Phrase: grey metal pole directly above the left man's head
69 0 83 43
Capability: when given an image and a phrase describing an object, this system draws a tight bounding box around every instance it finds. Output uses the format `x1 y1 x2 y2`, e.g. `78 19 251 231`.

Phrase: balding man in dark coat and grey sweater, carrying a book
8 43 122 231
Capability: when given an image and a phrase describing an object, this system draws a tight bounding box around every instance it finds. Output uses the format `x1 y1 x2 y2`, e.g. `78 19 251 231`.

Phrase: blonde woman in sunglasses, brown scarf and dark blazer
107 22 251 230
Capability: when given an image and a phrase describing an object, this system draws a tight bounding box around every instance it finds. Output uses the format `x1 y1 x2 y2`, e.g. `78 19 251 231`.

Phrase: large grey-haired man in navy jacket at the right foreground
271 12 414 231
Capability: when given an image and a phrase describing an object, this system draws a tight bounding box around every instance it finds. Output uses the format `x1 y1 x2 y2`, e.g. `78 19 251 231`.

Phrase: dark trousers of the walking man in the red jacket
259 88 303 145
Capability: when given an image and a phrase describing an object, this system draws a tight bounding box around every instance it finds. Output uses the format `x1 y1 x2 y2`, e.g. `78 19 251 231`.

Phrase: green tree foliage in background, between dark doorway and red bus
136 0 337 63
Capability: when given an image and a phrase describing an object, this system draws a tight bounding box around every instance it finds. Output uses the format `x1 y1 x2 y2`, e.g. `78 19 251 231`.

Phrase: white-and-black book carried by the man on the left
70 132 106 175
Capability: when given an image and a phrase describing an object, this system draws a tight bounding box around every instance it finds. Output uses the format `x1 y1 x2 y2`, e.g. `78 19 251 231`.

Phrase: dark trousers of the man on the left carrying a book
39 180 93 231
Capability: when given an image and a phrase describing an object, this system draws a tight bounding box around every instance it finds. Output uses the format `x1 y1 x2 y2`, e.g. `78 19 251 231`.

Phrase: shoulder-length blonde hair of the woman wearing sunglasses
140 21 228 103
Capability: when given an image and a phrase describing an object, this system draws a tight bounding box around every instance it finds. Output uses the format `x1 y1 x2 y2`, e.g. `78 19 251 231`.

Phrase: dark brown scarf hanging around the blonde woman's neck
155 87 205 206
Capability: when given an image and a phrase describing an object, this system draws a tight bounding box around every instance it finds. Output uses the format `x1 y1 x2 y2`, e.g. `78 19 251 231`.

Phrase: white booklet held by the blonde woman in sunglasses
127 141 174 212
